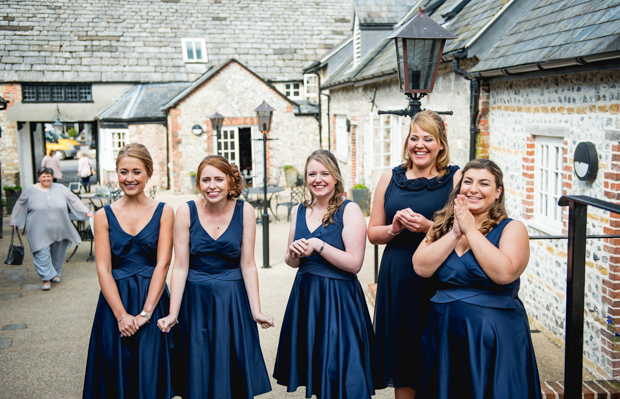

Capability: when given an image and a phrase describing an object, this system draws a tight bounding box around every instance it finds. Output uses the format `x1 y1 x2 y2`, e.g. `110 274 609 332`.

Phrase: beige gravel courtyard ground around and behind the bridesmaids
0 192 594 399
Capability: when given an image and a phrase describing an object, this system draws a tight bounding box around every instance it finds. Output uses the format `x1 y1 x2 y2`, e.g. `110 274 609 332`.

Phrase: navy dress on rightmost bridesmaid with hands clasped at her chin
416 219 541 399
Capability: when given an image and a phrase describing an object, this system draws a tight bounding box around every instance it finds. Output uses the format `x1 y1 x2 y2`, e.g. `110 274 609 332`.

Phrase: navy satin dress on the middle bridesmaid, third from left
273 200 374 399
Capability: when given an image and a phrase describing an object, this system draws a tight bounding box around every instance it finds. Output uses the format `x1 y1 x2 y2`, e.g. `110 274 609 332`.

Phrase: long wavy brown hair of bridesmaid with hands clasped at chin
426 159 508 243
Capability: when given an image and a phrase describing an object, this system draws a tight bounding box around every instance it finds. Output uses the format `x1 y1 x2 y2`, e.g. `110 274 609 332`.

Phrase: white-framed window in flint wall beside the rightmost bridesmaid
534 136 564 231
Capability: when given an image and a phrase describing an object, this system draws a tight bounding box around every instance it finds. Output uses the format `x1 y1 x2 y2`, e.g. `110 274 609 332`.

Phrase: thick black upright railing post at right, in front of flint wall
564 201 588 399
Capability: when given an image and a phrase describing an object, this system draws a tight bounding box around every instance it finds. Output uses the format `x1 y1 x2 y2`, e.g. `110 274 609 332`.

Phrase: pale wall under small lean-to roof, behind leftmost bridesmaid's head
127 124 168 189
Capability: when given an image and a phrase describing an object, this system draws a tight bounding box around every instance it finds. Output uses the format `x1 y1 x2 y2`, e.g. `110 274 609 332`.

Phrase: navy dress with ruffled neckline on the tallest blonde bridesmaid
373 166 458 389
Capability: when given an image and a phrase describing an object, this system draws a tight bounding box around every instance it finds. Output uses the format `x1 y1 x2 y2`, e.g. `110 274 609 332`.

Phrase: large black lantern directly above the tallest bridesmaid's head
379 7 457 118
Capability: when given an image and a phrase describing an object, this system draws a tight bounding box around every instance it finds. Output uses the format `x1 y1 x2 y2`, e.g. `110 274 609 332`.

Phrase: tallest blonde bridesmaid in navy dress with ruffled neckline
368 111 461 399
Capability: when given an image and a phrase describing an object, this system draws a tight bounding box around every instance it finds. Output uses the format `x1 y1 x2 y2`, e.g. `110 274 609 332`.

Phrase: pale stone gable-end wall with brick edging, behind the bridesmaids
168 62 319 193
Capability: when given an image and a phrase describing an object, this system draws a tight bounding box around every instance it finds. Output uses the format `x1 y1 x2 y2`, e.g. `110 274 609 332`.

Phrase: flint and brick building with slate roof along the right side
305 0 620 378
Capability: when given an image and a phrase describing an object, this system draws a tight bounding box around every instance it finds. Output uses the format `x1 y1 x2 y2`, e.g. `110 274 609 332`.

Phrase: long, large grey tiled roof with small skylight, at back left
0 0 354 83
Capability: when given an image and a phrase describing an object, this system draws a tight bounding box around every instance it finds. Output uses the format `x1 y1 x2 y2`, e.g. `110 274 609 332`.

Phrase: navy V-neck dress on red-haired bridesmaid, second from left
174 200 271 399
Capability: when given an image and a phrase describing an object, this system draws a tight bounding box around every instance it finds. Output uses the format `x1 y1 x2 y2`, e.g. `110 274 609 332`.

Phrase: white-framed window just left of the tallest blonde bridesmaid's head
370 113 402 170
